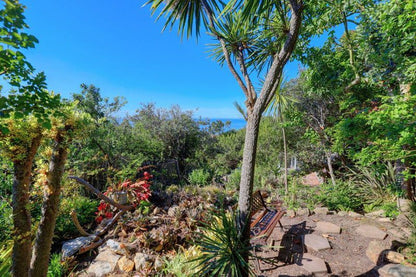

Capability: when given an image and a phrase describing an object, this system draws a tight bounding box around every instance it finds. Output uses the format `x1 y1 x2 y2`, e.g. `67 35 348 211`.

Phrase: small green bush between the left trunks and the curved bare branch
55 196 98 239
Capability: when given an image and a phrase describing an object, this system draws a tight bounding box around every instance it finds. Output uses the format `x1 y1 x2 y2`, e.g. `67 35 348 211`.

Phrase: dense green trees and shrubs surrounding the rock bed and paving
0 0 416 276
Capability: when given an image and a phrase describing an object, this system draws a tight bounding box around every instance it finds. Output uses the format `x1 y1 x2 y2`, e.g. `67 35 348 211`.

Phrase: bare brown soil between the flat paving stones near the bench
254 211 404 276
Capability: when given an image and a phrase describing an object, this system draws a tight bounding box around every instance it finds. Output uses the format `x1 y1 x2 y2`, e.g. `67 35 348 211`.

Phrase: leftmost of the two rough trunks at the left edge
12 135 42 277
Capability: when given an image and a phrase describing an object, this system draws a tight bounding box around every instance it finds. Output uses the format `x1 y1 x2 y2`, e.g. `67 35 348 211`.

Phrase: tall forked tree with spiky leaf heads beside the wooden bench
147 0 304 268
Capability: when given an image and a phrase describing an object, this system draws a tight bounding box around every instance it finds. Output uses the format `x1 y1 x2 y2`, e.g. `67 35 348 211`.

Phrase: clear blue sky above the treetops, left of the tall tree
22 0 308 118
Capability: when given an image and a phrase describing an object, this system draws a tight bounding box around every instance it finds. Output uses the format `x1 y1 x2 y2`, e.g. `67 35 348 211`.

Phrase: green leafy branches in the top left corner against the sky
0 0 60 130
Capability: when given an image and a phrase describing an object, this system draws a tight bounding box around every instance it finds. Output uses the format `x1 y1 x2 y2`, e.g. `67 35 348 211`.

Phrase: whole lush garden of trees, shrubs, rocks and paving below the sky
0 0 416 277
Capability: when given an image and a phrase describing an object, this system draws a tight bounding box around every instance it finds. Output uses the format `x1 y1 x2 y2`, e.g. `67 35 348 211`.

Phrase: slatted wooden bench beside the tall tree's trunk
250 190 286 245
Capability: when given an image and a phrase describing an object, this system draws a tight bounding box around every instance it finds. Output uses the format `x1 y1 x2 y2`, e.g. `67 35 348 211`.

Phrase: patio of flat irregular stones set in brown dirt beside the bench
254 208 416 277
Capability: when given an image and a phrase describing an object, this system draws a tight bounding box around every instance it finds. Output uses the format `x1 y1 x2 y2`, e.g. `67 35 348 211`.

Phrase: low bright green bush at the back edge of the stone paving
318 182 365 211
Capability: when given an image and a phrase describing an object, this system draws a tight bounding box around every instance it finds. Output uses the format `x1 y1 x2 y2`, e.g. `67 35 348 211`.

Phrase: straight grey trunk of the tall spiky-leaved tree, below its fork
238 112 261 276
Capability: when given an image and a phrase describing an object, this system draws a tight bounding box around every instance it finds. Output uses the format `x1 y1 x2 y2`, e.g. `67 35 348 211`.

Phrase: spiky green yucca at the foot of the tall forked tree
194 210 254 276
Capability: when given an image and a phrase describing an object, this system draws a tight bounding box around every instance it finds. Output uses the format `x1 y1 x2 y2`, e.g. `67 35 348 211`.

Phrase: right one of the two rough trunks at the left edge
30 131 68 277
